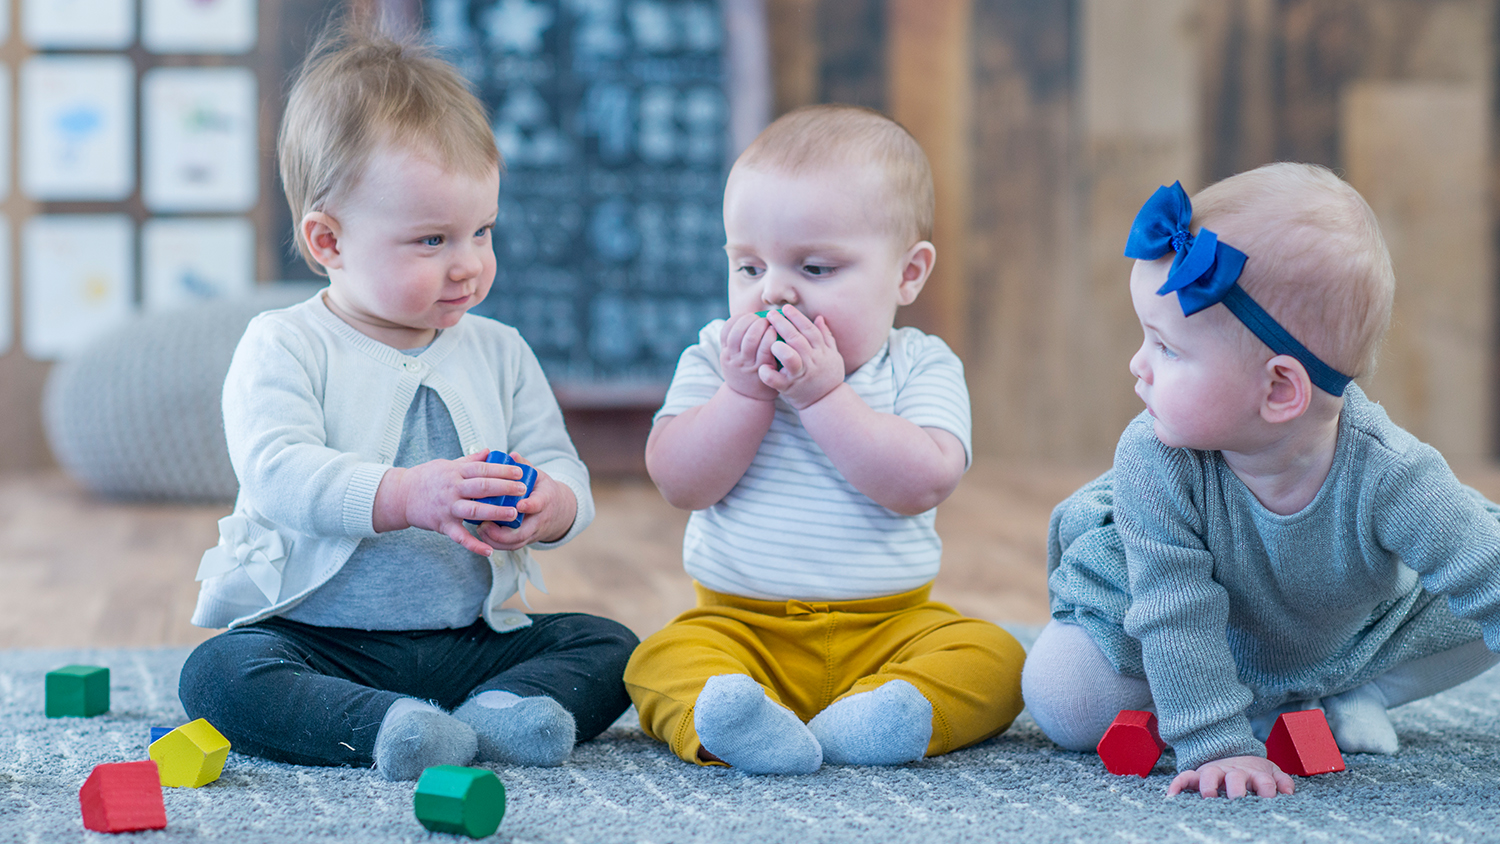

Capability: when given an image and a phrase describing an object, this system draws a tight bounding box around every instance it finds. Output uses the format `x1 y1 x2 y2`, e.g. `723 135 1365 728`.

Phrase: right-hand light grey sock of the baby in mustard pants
807 681 933 765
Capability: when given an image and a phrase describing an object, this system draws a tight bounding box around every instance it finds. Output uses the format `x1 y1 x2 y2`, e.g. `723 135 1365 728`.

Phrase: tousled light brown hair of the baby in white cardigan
276 21 501 274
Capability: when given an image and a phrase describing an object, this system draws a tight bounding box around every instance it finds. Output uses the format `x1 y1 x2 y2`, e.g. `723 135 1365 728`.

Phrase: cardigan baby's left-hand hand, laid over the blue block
372 451 542 555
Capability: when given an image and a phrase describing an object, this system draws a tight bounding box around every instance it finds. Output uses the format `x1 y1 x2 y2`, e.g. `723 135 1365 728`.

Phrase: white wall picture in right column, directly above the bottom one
141 67 258 211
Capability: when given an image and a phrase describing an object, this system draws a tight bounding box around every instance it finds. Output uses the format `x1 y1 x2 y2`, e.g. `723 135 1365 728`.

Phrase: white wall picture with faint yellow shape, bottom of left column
21 214 135 360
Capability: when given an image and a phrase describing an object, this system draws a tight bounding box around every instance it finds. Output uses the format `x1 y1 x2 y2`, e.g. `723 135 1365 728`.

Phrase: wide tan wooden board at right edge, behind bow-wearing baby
1341 82 1494 460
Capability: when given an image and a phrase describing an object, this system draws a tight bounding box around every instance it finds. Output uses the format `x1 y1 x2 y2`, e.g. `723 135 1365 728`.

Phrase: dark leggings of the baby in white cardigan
177 613 638 766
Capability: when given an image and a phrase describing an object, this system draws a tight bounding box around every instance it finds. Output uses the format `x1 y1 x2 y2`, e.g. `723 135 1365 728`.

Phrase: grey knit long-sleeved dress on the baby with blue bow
1047 385 1500 771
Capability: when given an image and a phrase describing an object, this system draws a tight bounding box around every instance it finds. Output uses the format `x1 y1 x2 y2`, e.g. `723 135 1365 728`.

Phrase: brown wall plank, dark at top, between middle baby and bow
965 0 1082 457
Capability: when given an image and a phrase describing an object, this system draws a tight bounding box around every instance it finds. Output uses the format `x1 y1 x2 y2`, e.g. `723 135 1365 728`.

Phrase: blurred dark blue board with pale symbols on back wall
425 0 729 393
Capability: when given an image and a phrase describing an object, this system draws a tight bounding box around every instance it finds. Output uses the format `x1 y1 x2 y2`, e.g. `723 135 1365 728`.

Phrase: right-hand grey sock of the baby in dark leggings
453 690 578 768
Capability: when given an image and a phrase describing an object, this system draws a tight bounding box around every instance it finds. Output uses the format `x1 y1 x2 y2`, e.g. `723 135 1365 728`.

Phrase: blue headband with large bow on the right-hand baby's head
1125 181 1353 396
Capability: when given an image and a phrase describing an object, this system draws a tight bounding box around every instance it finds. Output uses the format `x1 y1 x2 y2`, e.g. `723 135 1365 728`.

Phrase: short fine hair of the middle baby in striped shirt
735 105 933 246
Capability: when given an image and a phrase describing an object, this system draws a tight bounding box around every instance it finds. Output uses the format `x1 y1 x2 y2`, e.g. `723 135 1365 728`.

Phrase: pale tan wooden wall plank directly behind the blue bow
1074 0 1199 457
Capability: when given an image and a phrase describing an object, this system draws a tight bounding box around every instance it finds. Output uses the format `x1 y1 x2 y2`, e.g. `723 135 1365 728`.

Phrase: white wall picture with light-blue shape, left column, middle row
21 55 135 201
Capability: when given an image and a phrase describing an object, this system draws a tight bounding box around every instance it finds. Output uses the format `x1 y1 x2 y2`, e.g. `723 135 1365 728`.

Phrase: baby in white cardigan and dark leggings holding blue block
180 23 636 780
